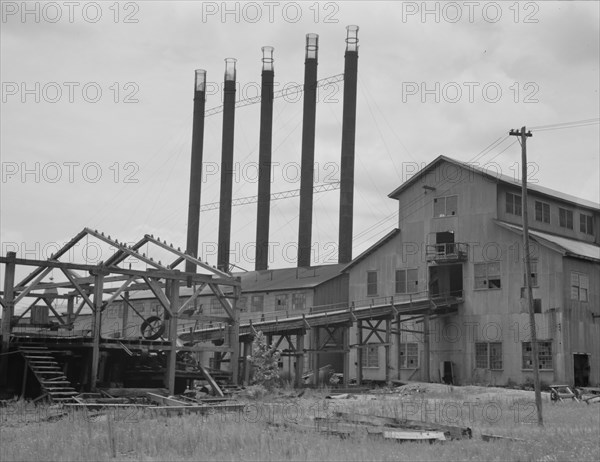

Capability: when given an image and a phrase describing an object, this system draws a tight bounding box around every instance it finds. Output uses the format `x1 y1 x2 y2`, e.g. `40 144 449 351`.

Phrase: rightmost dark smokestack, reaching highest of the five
338 26 358 263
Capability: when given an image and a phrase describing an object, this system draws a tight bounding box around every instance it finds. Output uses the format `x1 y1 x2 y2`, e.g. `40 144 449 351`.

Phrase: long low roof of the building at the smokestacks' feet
130 263 345 300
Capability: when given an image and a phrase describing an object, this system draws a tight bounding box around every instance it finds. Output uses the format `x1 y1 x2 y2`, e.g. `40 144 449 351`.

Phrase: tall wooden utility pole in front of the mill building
508 126 544 427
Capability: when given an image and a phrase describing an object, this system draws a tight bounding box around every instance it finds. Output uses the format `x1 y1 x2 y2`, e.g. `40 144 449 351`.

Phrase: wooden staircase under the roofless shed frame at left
19 346 79 403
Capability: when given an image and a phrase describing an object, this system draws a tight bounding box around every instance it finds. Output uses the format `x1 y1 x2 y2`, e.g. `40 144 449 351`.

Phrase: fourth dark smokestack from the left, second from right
298 34 319 266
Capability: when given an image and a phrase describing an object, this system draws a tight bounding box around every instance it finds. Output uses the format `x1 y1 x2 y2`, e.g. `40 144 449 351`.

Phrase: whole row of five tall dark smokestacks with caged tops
186 26 358 272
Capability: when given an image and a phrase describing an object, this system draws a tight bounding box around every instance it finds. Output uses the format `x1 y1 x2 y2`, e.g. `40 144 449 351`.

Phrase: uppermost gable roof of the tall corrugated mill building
388 156 600 211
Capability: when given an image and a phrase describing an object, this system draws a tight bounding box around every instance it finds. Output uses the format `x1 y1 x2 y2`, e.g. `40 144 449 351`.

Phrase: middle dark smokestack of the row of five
254 47 275 271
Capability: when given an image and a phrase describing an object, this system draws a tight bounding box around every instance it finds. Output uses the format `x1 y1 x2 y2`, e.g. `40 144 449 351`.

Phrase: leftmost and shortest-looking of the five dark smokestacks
185 69 206 274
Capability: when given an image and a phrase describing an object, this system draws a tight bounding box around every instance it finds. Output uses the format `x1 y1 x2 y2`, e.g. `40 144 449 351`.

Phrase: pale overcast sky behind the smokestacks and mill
0 1 600 278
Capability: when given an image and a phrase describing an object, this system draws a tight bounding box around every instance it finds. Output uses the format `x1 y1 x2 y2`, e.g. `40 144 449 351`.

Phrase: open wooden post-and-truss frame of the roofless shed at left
0 228 241 393
